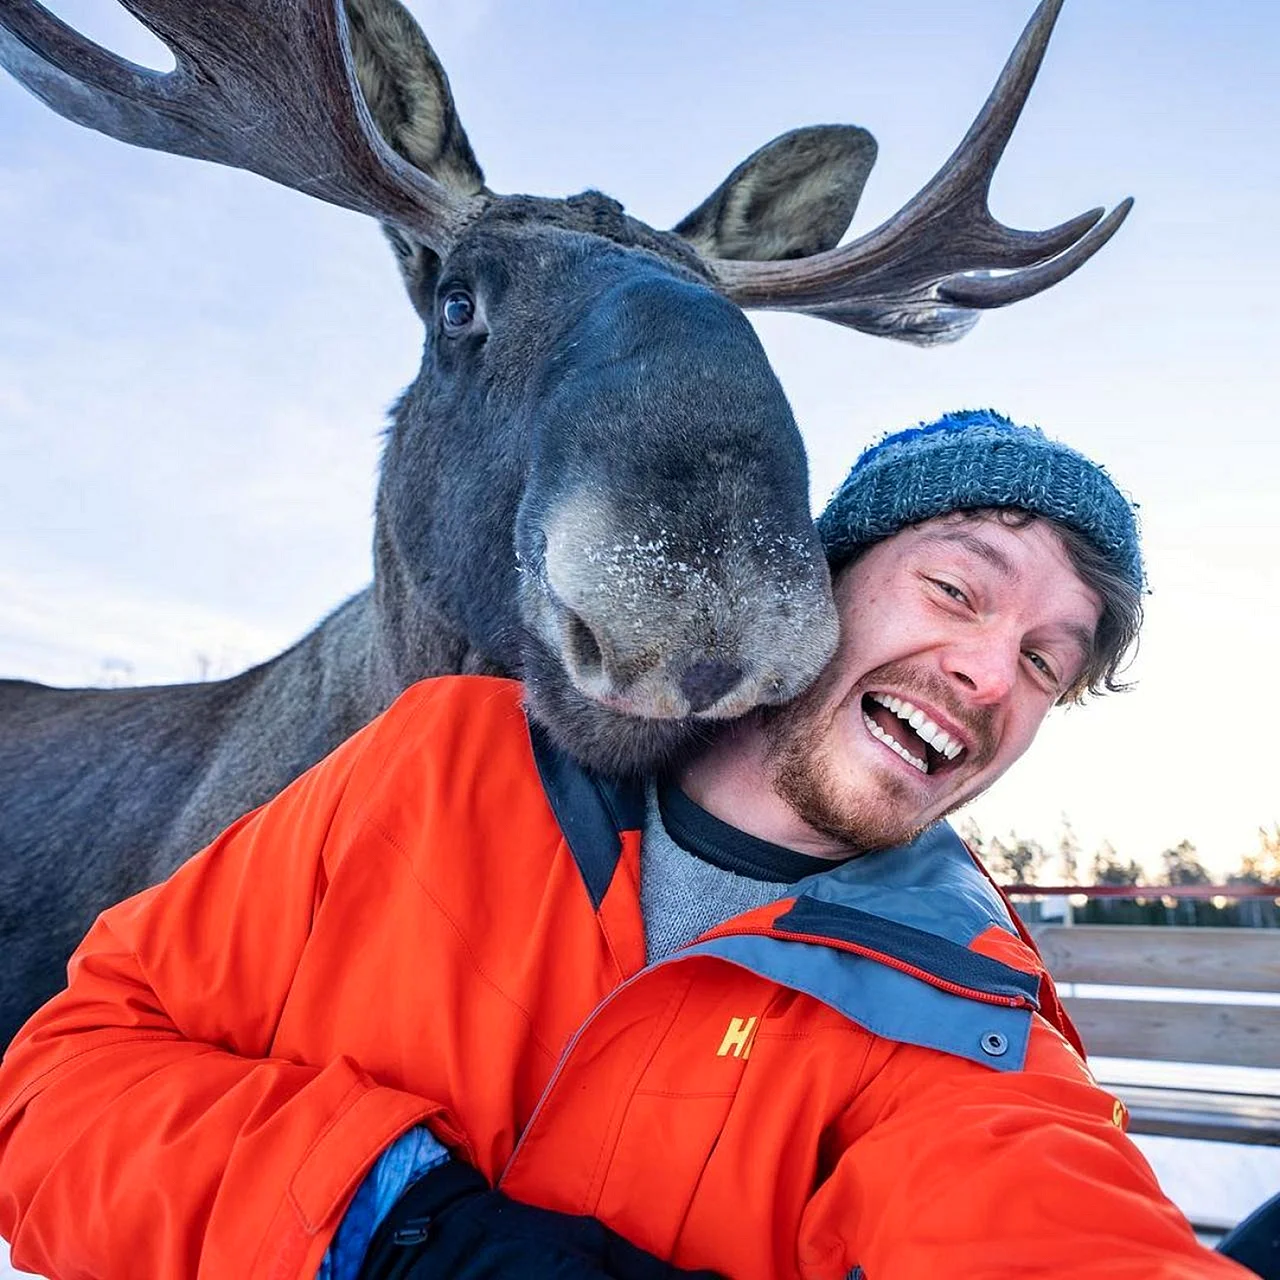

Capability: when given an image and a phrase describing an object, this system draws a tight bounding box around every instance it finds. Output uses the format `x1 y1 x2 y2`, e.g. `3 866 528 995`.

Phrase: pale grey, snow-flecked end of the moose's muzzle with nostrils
525 504 838 719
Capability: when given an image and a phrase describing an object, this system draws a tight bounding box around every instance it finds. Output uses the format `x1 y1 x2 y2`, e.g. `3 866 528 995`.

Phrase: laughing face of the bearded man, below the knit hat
765 515 1101 850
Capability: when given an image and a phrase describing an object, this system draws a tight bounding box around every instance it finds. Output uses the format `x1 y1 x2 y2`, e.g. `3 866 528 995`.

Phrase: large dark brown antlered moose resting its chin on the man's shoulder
0 0 1129 1039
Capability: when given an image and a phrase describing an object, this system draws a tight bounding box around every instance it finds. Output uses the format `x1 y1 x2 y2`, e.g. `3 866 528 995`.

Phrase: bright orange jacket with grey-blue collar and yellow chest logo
0 677 1243 1280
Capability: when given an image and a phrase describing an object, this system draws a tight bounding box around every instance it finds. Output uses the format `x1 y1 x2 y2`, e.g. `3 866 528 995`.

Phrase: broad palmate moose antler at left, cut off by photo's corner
0 0 480 251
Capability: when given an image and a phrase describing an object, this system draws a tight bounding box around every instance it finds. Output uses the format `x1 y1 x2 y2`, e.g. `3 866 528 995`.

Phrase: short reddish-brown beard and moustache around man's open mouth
760 662 996 854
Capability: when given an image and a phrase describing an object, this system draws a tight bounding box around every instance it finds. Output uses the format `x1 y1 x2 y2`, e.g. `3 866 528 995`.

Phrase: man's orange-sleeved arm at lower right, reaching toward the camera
801 1018 1247 1280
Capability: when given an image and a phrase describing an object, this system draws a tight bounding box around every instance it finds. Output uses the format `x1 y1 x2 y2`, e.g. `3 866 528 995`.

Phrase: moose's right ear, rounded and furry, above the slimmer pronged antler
673 124 877 261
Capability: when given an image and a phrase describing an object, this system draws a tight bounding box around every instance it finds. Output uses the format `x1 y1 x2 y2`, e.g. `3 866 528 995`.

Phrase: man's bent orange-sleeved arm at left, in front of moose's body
0 695 462 1280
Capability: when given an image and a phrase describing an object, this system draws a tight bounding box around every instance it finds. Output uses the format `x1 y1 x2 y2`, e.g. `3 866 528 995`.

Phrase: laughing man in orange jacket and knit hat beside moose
0 413 1243 1280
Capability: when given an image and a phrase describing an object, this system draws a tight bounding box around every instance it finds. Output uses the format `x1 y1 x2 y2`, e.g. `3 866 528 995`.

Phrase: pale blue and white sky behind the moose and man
0 0 1280 872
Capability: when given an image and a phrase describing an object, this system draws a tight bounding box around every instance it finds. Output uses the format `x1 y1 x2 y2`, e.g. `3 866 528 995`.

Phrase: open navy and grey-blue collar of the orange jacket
530 724 1038 1071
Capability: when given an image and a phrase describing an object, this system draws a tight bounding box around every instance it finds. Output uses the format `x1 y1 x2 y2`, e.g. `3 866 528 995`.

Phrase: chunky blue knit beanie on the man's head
818 410 1143 591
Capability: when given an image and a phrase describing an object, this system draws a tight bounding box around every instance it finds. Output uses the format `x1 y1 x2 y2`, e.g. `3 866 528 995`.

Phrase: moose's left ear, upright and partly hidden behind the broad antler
347 0 485 320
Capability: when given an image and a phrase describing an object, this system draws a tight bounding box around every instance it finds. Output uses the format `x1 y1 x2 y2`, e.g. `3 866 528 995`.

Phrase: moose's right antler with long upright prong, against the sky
710 0 1133 344
